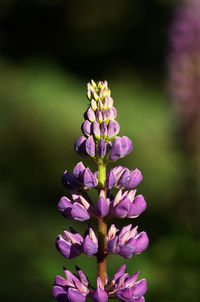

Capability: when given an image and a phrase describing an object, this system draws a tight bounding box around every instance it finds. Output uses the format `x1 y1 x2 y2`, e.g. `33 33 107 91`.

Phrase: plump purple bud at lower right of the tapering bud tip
109 136 133 161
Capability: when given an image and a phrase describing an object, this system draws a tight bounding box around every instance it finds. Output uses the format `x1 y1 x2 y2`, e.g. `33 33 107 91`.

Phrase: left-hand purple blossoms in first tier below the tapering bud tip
62 162 97 191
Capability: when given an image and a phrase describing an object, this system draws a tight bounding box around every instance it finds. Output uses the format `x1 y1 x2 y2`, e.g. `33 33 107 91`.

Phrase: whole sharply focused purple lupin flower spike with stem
53 81 149 302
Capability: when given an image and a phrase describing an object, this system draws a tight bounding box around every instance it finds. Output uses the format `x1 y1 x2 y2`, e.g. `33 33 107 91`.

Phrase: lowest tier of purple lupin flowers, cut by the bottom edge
53 264 147 302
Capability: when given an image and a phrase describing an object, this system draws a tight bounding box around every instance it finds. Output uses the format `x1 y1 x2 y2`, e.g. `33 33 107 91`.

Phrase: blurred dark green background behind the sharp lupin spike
0 0 200 302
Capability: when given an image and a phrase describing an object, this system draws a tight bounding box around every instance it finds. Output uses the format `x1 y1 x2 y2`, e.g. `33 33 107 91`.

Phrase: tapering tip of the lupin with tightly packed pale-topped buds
75 81 133 161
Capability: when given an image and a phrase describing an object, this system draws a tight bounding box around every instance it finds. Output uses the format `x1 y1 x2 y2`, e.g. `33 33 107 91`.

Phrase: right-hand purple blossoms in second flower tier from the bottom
107 224 149 258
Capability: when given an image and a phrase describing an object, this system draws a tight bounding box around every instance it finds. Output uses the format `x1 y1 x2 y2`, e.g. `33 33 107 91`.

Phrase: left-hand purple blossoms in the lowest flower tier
53 269 89 302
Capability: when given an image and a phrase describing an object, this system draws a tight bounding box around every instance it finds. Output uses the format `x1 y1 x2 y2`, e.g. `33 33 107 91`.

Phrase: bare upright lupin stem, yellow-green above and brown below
97 162 107 286
